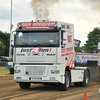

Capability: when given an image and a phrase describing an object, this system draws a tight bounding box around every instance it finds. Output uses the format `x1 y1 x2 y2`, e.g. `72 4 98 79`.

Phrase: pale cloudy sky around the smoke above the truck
0 0 100 46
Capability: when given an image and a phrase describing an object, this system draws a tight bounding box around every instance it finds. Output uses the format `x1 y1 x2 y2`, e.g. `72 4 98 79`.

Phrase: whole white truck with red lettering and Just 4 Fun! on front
13 21 90 90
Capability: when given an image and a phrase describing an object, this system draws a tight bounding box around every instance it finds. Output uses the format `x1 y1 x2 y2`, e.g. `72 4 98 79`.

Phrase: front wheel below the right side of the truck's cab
60 71 71 91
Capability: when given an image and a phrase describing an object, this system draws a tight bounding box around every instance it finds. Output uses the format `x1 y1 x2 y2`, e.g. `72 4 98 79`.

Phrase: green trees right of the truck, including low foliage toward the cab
76 27 100 53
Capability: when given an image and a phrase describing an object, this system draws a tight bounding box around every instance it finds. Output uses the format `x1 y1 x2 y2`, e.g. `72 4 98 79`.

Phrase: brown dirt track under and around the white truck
0 77 100 100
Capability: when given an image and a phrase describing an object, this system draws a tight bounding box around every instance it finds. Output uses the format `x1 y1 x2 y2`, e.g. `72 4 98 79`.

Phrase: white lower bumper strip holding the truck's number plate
14 76 64 83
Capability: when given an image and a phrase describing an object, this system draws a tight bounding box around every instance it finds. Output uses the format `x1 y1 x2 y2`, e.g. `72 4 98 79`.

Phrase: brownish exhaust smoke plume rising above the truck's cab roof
30 0 59 20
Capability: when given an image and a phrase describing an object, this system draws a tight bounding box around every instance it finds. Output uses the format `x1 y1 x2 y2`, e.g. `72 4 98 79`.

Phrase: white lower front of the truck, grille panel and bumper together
14 65 64 84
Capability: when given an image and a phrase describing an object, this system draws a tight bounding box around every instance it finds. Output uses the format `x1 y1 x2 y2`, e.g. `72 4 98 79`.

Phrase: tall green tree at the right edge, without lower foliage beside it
84 27 100 53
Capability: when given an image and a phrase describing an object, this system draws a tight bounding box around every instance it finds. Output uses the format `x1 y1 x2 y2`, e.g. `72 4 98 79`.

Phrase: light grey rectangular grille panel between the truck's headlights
26 66 45 75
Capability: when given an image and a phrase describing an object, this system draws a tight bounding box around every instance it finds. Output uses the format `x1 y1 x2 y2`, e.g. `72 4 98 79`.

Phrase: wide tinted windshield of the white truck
15 32 59 47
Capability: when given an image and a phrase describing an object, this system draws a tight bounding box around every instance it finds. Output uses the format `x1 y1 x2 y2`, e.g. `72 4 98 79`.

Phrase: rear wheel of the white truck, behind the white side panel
74 70 89 87
